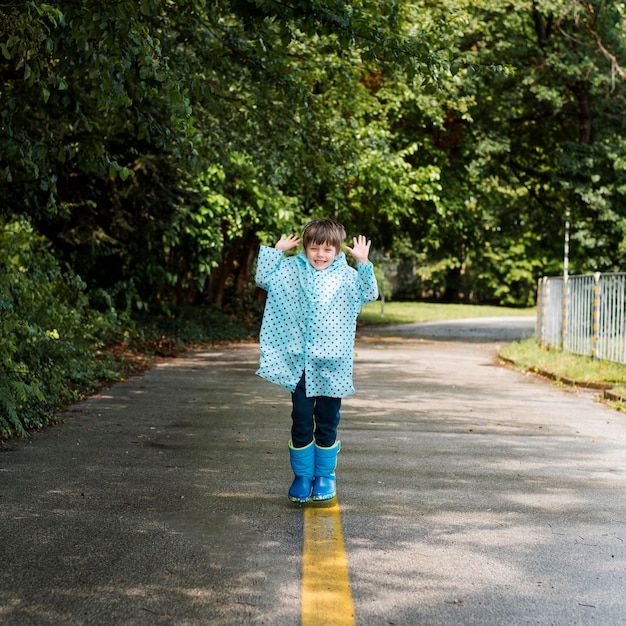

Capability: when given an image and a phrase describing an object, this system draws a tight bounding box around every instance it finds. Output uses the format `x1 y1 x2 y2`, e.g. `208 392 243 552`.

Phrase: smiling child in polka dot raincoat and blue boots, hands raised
255 220 378 502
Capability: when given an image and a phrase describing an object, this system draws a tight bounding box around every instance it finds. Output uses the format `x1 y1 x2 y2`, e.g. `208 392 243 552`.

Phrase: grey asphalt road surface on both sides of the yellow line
0 320 626 626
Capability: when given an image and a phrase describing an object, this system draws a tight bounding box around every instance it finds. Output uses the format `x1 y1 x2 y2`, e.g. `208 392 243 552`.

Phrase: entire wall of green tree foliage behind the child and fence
0 0 626 434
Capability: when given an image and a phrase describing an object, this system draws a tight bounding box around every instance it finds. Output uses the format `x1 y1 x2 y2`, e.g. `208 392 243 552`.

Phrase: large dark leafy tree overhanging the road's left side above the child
0 0 450 306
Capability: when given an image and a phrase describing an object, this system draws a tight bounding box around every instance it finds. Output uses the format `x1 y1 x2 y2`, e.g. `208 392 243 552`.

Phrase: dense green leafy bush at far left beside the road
0 220 129 439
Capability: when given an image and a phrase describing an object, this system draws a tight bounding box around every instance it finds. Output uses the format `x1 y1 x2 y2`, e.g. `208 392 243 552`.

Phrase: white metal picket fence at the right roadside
535 273 626 363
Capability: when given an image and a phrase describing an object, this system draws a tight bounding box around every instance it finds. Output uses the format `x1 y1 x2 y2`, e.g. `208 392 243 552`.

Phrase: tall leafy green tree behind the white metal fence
382 0 625 304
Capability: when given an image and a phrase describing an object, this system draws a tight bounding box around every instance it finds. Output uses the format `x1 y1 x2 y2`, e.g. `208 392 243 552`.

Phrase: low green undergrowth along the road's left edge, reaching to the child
0 220 259 440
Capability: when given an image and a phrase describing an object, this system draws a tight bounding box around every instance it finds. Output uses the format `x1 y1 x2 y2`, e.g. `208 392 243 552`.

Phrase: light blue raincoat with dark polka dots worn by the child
255 246 378 398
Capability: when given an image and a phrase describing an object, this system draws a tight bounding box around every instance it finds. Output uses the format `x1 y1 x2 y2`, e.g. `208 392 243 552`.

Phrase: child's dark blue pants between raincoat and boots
291 374 341 448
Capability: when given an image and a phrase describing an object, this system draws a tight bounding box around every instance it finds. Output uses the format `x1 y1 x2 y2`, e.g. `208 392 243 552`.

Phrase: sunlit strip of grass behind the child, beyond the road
359 301 536 324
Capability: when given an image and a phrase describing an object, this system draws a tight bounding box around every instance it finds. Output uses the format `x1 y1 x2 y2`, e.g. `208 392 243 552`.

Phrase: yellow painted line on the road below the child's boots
302 498 356 626
